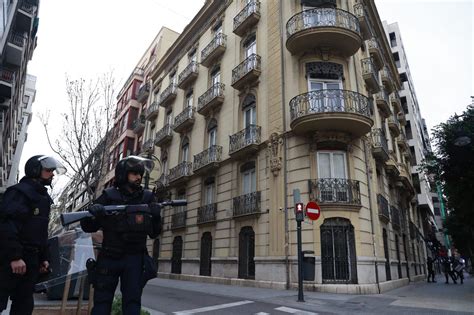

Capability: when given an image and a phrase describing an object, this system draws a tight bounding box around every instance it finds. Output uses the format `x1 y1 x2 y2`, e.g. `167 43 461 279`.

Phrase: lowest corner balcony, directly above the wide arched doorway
308 178 361 211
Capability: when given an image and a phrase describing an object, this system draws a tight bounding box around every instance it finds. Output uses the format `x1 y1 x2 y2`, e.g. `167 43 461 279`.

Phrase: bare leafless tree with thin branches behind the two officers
40 71 116 204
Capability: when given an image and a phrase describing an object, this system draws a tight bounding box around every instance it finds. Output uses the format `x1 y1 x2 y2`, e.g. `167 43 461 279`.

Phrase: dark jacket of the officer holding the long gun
81 187 161 255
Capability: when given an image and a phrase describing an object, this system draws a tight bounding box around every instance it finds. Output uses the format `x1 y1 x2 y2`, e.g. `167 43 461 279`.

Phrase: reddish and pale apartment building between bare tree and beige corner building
98 27 179 191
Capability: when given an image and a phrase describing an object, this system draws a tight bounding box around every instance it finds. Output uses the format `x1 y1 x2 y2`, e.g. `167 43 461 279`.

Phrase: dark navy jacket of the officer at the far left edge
0 177 53 261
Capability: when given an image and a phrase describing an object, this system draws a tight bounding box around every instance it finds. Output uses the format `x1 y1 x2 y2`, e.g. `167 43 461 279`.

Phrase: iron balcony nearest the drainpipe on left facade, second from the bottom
229 125 262 158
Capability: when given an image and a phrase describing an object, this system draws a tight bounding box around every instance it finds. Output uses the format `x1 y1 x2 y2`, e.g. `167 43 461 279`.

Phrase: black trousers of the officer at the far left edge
0 252 39 315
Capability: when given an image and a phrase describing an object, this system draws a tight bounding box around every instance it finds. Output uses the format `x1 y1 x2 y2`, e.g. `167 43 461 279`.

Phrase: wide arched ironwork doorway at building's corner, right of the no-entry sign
320 218 357 283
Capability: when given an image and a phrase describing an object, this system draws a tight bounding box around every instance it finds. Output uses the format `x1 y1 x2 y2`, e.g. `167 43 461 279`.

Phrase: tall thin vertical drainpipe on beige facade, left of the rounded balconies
279 0 291 290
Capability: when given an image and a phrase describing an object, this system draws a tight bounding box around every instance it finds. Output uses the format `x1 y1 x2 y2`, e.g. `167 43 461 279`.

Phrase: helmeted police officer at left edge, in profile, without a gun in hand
0 155 66 314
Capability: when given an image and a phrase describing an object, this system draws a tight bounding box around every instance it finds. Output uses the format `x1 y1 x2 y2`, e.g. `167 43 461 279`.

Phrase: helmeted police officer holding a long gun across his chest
81 156 161 315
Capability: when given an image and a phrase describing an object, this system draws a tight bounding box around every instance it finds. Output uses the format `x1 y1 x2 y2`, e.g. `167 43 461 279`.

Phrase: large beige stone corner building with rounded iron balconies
123 0 425 293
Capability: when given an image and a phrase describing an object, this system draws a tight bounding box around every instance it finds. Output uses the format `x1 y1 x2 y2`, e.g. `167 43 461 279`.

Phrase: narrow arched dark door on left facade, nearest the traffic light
239 226 255 279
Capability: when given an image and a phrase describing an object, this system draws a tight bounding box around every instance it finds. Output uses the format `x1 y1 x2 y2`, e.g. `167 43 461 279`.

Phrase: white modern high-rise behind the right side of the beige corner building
383 21 441 254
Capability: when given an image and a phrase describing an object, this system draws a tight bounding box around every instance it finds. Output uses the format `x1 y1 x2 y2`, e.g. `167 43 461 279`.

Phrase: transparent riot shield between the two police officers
35 228 96 299
